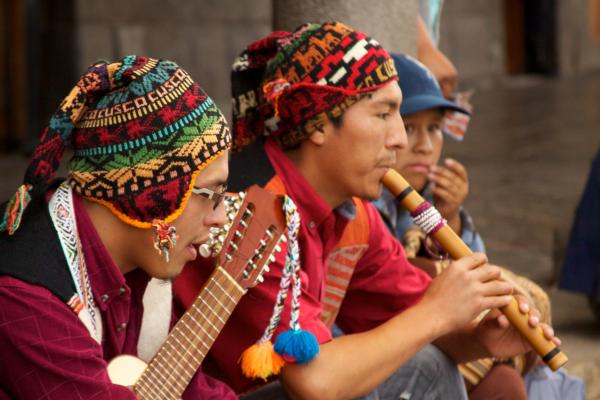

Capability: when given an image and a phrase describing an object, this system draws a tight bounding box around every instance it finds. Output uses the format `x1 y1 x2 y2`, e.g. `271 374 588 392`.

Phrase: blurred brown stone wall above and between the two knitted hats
76 0 272 116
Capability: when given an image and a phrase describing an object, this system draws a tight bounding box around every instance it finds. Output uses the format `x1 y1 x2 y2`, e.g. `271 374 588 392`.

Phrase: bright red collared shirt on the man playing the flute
174 144 430 393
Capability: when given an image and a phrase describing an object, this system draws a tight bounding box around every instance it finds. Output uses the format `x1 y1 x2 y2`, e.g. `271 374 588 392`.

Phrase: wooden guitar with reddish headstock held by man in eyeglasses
108 186 286 399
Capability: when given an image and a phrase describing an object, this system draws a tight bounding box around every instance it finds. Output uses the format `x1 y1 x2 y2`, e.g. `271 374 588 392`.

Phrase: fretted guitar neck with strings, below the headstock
133 267 246 399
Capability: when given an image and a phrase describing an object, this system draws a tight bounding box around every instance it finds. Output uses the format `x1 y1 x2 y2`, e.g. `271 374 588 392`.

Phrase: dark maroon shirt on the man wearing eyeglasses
0 192 236 400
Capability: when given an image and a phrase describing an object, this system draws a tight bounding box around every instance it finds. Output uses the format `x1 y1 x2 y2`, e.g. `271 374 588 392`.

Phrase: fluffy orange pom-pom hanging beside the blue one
240 341 285 380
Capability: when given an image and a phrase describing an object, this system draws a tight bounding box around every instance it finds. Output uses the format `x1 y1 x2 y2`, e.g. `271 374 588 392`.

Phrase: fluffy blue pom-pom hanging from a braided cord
274 329 319 364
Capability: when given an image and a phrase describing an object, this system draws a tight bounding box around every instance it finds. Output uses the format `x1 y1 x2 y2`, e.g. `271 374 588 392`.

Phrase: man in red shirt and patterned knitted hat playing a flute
180 22 558 399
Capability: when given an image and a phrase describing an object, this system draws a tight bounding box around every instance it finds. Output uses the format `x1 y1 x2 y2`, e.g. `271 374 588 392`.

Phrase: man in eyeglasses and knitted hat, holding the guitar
0 56 236 399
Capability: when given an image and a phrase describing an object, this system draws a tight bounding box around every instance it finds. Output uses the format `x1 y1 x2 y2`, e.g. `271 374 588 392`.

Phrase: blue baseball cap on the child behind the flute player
392 54 470 115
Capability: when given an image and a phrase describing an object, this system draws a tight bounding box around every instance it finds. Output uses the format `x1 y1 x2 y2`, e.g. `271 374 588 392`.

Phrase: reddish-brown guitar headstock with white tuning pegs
200 185 286 289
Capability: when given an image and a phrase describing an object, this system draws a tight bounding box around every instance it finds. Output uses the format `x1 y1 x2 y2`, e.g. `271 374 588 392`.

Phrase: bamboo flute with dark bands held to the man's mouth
382 169 569 371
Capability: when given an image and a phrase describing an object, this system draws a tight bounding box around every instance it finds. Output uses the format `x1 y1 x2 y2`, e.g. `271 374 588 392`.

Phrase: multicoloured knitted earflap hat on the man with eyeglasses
0 56 231 234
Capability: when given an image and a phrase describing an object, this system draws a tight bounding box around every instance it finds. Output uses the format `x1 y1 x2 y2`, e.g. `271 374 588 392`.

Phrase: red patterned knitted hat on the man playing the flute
231 21 398 152
